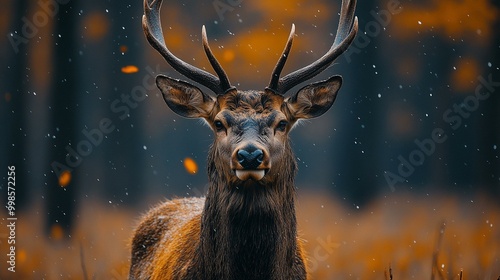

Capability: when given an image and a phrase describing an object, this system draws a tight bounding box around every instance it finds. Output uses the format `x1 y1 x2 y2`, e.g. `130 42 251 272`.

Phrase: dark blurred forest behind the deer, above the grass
0 0 500 276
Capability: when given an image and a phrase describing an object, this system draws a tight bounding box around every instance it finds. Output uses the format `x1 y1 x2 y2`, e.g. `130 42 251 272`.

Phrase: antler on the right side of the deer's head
267 0 358 94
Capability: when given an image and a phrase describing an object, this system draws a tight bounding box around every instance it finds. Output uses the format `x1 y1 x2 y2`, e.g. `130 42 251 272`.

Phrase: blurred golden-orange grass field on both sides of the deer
0 193 500 280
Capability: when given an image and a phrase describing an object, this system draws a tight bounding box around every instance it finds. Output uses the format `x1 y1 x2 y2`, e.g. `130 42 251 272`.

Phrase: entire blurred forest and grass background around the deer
0 0 500 279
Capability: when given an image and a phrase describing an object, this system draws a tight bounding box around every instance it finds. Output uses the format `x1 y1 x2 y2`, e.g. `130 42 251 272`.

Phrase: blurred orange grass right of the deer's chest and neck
298 194 500 279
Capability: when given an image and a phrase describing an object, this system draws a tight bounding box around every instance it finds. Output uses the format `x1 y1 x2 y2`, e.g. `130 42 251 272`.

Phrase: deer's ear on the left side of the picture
156 75 215 118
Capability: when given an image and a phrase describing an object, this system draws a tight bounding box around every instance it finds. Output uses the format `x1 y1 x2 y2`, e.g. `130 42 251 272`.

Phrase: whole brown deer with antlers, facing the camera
129 0 358 280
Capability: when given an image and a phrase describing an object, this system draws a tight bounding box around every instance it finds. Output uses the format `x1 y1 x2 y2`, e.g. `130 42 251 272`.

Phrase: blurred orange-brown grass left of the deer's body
0 203 133 280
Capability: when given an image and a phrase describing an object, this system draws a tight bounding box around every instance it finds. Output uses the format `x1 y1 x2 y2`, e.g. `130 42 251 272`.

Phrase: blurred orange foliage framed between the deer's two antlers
157 0 340 87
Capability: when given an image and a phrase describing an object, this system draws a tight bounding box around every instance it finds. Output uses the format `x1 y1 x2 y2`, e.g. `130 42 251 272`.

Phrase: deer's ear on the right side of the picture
286 76 342 119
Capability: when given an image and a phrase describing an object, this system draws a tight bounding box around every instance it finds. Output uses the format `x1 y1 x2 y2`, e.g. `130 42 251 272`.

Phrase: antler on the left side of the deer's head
142 0 234 95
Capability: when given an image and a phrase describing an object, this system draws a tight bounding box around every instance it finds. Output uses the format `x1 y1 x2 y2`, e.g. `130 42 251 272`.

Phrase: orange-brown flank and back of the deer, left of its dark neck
130 198 205 279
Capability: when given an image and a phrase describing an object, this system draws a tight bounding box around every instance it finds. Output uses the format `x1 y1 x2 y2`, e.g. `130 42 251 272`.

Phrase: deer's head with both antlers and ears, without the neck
143 0 358 184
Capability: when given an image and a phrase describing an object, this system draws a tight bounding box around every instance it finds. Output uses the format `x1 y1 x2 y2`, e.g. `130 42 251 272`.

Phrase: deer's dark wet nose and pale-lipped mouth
231 144 270 181
